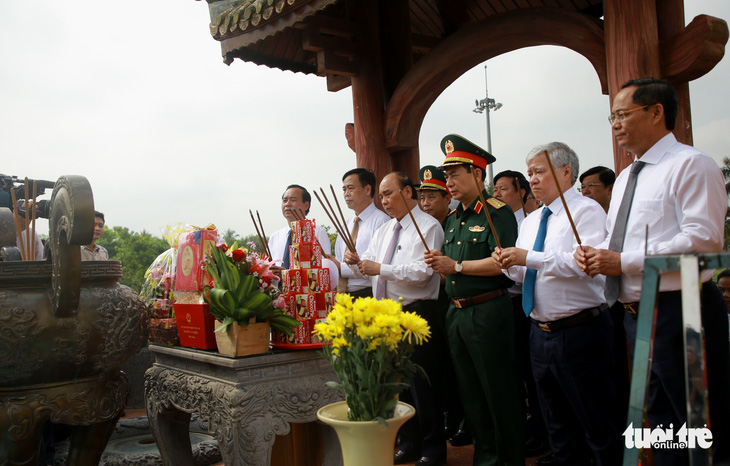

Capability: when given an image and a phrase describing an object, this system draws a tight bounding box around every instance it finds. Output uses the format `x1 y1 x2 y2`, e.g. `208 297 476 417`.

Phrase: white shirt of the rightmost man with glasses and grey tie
599 133 727 303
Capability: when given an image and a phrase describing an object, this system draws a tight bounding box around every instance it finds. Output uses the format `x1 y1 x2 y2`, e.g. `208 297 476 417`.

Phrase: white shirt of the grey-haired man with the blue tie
503 188 606 321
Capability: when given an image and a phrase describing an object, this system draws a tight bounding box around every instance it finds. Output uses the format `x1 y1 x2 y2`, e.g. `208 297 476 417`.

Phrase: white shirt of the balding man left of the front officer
349 205 444 306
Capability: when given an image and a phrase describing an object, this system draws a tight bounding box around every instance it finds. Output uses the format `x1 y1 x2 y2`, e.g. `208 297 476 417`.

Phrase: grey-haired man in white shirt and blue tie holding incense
492 142 623 465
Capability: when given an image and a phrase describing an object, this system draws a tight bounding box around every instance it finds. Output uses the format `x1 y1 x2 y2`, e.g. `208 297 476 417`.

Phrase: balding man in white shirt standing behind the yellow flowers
344 172 446 466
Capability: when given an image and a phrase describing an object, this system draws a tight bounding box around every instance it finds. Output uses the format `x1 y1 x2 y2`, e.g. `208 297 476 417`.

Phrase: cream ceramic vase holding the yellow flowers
317 401 416 466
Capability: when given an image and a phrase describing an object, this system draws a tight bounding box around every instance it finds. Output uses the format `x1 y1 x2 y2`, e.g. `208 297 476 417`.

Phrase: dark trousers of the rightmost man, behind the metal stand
624 281 730 466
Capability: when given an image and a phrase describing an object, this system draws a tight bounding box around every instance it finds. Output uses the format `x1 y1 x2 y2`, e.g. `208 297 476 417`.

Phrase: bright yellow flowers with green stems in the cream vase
314 293 431 424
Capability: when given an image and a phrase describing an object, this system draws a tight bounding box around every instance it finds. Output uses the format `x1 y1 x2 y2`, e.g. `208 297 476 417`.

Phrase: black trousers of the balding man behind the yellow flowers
398 300 448 459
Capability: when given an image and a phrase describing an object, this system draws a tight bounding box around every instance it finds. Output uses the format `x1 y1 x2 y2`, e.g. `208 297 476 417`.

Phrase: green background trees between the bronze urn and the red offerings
97 226 170 292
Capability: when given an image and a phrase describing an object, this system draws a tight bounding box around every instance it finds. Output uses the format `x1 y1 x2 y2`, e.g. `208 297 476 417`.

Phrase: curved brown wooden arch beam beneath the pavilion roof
378 7 608 151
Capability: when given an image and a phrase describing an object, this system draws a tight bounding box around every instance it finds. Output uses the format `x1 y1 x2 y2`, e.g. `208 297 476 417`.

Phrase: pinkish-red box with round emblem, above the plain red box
175 230 218 291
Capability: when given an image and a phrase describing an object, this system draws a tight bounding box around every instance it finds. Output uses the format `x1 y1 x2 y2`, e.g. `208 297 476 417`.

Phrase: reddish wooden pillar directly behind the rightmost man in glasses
603 0 661 173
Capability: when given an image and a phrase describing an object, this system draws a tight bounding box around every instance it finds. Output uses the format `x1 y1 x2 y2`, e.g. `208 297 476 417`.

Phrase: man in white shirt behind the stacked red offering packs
269 184 332 270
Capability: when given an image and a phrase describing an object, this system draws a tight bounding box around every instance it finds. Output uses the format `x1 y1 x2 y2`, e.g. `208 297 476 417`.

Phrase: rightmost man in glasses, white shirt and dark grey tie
575 78 730 465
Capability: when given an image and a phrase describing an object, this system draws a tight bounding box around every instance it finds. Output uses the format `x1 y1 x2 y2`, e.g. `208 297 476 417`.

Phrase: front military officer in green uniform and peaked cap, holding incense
426 134 525 466
